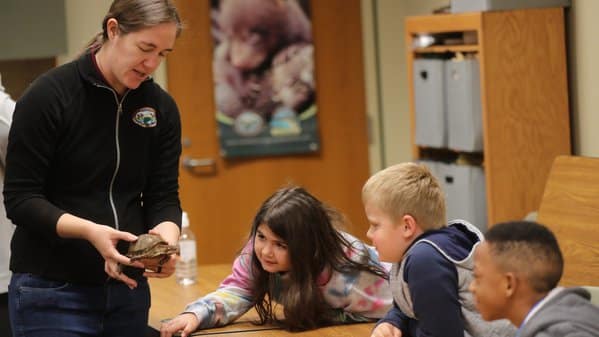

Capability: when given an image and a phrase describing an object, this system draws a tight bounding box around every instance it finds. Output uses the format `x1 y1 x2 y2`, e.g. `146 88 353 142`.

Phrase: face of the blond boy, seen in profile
364 203 410 262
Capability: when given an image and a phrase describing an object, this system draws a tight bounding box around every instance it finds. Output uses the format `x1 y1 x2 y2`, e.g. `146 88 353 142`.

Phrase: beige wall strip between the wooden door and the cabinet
362 0 448 172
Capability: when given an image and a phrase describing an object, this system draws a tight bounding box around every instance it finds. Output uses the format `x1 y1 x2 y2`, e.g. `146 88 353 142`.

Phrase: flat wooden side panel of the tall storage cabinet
481 8 571 222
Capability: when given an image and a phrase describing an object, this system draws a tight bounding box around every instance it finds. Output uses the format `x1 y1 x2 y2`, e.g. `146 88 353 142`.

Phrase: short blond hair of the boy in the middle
362 162 446 231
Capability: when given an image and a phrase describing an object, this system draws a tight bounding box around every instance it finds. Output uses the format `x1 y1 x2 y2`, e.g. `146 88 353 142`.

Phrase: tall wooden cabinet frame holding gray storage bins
405 8 571 224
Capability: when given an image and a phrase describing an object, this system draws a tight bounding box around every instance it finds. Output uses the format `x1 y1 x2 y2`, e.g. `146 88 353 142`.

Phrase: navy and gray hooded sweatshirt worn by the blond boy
379 220 516 337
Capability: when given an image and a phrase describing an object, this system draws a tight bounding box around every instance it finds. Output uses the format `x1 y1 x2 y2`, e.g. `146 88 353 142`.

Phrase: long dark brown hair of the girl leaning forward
250 187 386 331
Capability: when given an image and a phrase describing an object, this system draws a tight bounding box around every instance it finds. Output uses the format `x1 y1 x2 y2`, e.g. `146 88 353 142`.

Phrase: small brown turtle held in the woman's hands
125 234 179 269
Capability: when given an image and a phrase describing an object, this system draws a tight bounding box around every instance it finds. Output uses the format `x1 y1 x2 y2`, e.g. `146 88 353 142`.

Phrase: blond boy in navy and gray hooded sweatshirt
362 163 515 337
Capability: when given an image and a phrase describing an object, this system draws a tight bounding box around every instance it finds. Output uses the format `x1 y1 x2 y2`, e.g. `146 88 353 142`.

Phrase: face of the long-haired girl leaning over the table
254 224 291 273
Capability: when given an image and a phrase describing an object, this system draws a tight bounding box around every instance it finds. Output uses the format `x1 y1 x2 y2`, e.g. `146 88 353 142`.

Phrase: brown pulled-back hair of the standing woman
86 0 183 49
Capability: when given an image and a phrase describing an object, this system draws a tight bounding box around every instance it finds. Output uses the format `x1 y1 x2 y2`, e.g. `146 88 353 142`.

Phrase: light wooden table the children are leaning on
148 264 374 337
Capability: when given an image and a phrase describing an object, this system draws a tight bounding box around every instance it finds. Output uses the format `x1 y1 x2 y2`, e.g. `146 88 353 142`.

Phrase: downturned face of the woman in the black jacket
99 19 177 94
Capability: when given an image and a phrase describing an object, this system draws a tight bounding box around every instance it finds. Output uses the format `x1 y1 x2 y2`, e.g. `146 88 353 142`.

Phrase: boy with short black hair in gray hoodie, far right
470 221 599 337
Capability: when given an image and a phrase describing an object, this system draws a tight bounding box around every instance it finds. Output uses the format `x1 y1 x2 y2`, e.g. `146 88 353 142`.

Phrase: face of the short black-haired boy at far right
469 242 508 321
